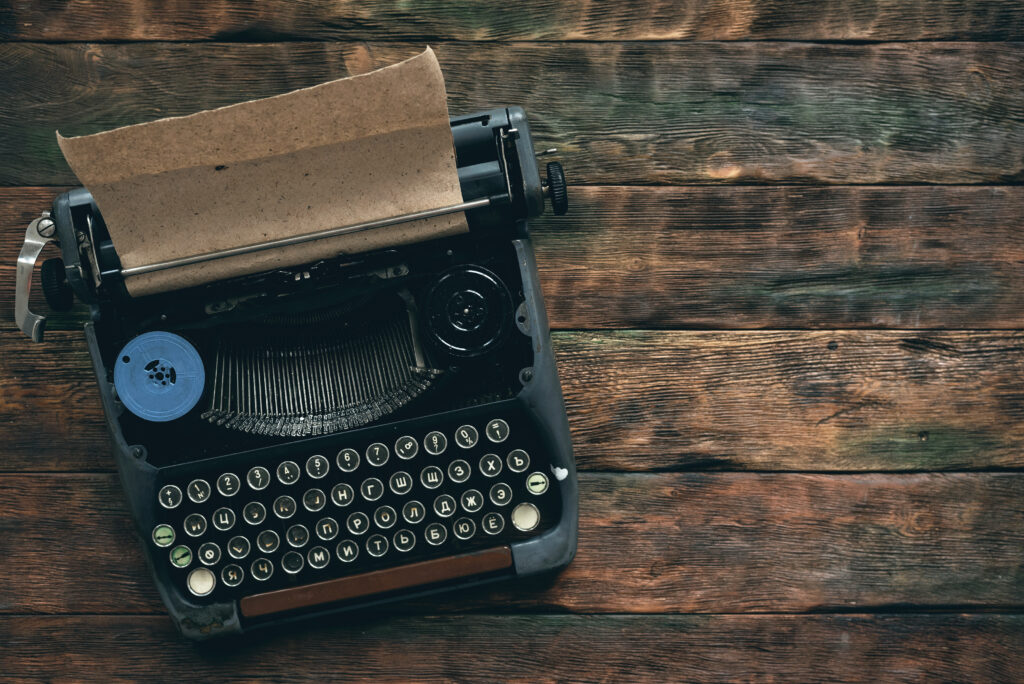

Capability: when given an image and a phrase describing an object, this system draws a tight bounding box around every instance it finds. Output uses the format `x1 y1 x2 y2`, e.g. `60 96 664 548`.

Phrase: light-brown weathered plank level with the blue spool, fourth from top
0 331 1024 472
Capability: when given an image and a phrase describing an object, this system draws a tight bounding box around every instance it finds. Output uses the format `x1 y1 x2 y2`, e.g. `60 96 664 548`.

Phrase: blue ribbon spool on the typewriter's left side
114 331 206 423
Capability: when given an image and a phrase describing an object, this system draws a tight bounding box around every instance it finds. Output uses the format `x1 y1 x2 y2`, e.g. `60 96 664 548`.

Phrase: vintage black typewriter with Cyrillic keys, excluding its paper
15 106 577 640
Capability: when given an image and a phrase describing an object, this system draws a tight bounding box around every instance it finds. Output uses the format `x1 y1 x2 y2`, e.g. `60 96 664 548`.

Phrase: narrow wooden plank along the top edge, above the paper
0 0 1024 41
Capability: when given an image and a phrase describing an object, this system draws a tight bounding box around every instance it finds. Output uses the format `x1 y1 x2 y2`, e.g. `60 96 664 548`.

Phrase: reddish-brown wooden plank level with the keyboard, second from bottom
0 473 1024 613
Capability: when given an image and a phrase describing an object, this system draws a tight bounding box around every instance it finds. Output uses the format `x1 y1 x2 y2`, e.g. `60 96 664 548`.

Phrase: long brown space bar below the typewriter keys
240 546 512 617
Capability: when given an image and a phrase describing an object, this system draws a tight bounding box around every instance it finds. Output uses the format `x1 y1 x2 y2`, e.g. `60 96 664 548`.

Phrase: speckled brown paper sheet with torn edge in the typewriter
57 48 468 296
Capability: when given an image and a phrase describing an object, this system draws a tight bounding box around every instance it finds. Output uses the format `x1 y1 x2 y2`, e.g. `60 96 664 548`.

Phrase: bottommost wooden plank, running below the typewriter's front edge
0 614 1024 683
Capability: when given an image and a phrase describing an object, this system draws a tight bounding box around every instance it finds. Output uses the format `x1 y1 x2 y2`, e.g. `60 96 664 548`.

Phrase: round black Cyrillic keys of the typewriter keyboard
152 418 564 601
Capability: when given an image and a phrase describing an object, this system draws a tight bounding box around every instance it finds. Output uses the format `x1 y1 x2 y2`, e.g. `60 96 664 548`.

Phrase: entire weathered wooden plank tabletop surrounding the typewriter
0 0 1024 682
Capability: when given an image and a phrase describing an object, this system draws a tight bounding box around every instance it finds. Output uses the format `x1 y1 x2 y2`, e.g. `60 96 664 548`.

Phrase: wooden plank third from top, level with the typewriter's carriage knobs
8 186 1024 330
